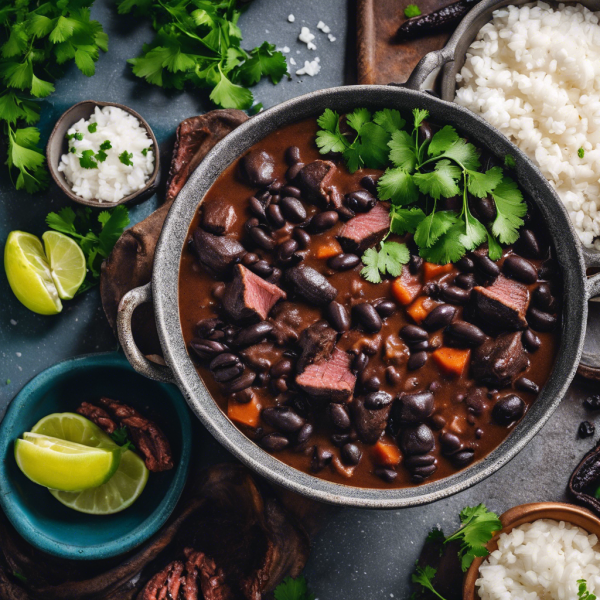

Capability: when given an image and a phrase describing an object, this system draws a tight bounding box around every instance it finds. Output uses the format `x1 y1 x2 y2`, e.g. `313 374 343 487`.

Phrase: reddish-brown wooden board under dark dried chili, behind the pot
357 0 455 85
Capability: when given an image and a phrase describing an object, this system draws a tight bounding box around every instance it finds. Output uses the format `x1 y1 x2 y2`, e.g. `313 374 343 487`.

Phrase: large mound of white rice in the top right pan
456 2 600 249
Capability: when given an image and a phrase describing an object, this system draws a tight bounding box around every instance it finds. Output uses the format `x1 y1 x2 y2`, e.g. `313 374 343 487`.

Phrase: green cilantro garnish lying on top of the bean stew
316 108 527 270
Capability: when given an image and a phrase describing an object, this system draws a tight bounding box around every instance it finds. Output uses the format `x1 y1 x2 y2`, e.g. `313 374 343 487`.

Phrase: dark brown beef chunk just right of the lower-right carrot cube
471 332 529 386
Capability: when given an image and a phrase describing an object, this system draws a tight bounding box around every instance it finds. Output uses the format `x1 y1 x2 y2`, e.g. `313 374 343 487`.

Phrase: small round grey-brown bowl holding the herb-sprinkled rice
46 100 160 208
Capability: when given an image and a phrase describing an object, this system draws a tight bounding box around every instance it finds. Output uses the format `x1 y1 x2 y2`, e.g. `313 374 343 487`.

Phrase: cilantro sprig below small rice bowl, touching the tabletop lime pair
46 205 129 294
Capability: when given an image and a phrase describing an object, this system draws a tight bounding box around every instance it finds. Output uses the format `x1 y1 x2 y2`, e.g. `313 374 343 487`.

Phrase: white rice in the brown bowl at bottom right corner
476 519 600 600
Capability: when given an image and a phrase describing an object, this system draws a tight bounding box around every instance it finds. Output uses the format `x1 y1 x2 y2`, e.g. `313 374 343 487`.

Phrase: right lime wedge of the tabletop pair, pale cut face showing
42 231 87 300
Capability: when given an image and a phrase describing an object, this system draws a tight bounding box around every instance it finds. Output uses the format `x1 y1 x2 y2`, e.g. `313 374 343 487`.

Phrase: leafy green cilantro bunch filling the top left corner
0 0 108 193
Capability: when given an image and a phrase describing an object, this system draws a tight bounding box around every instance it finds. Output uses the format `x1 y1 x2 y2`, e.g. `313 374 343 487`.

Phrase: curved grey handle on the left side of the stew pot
117 282 175 383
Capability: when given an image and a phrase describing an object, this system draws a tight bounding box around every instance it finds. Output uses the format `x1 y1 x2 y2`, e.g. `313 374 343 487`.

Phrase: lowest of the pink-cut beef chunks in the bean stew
296 348 356 402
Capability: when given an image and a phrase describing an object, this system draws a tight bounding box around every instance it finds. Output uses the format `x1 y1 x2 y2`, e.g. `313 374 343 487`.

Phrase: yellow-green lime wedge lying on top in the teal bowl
15 433 121 492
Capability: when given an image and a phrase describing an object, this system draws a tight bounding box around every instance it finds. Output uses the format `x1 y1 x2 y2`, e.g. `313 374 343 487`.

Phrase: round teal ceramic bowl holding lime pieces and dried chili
0 353 192 560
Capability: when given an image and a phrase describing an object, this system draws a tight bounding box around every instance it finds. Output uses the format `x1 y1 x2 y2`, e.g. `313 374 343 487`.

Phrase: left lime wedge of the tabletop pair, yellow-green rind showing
4 231 62 315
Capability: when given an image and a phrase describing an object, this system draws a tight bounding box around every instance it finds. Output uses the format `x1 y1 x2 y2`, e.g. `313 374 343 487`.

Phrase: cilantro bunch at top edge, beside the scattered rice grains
118 0 289 109
